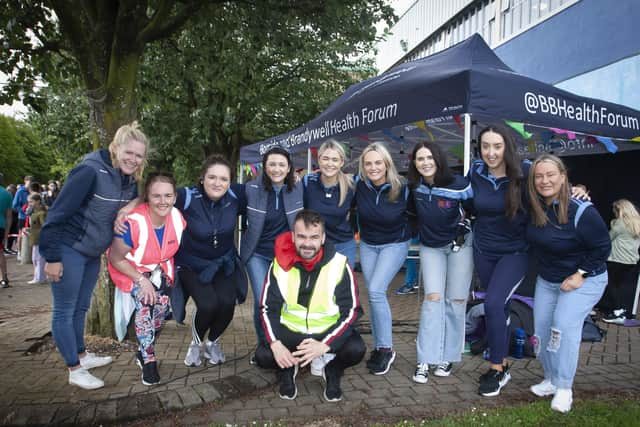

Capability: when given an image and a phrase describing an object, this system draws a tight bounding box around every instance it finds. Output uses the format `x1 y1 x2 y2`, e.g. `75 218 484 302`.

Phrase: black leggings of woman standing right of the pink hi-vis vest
178 270 236 343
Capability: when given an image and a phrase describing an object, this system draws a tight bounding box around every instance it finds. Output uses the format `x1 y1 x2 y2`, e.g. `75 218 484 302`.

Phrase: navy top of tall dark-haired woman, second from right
469 160 531 256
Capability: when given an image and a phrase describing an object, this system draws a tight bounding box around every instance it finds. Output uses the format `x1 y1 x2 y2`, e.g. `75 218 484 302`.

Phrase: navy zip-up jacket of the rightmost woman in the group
527 199 611 283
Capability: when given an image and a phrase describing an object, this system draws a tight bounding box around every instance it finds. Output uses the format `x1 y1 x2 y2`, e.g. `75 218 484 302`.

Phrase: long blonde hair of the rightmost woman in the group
528 154 569 227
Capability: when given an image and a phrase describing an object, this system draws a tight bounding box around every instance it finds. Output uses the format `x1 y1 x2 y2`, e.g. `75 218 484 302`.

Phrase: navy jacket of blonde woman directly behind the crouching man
303 173 355 243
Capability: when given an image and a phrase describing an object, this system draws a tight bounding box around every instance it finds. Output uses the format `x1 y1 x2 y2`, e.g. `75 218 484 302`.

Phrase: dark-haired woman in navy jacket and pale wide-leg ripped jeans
408 142 473 383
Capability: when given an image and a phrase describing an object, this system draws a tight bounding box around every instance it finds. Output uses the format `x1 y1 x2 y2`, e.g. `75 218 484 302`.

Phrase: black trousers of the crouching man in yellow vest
256 327 367 372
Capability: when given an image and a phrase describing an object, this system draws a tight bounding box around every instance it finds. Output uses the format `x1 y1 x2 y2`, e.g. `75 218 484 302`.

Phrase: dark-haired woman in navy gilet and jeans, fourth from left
240 147 304 344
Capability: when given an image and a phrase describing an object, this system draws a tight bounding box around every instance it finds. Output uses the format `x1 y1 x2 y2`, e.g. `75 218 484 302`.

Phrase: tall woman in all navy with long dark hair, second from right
469 126 530 396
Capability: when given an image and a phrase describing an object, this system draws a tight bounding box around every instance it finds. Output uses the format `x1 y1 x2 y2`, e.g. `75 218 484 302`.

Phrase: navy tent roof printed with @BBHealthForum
240 34 640 163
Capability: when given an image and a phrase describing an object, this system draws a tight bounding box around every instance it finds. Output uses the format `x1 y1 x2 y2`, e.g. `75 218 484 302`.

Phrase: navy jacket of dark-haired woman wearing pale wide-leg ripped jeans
412 175 473 248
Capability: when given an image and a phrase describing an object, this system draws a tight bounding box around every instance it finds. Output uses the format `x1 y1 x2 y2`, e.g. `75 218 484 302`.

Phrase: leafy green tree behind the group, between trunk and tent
141 0 393 184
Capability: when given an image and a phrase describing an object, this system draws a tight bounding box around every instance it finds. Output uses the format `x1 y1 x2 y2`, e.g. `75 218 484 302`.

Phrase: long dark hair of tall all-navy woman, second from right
478 125 525 219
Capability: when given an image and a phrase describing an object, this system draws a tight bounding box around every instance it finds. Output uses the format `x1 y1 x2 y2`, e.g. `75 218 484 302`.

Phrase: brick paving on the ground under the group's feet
0 257 640 426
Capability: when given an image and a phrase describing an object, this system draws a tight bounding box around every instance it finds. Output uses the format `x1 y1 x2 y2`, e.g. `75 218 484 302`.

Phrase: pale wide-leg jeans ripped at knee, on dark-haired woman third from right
416 233 473 365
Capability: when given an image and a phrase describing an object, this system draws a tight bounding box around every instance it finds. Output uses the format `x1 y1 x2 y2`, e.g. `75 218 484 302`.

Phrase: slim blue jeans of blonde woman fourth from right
360 240 409 348
